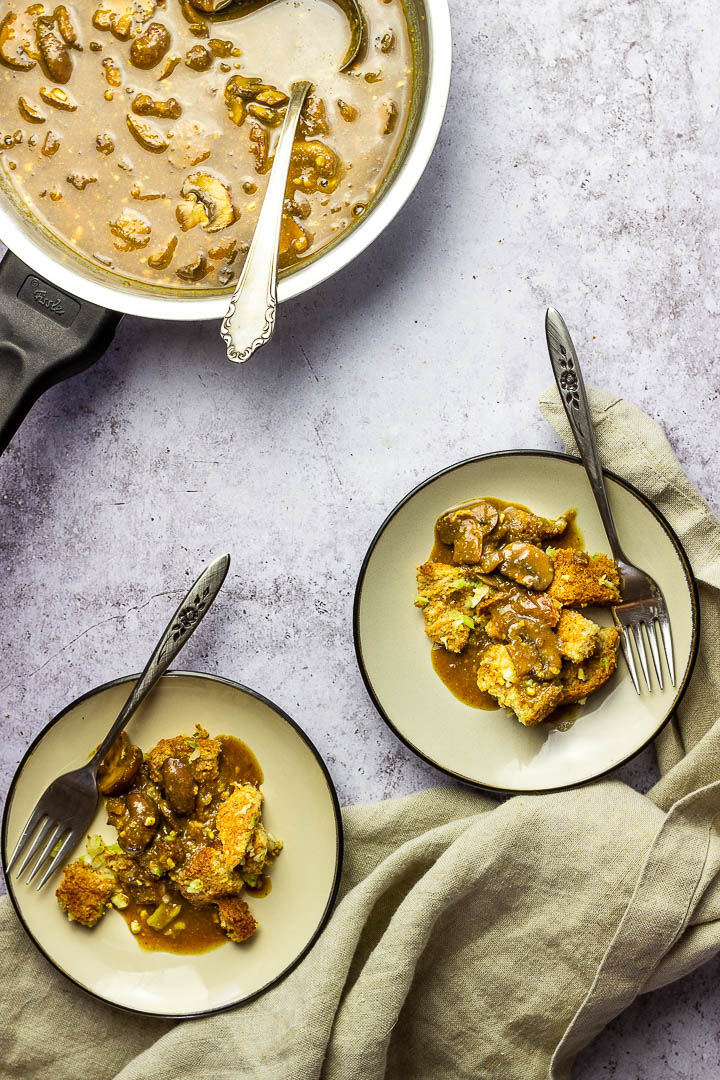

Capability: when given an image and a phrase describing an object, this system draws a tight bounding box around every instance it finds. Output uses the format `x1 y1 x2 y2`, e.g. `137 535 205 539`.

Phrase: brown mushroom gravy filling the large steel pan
0 0 413 288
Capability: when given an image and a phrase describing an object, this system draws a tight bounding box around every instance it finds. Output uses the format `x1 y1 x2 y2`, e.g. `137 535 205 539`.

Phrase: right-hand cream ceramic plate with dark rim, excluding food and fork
354 450 698 793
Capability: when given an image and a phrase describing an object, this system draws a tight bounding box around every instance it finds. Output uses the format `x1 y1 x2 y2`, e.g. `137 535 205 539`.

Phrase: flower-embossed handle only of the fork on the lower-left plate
89 555 230 770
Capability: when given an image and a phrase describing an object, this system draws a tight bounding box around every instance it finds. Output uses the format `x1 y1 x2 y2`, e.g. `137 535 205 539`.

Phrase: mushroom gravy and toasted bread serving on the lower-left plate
56 725 283 953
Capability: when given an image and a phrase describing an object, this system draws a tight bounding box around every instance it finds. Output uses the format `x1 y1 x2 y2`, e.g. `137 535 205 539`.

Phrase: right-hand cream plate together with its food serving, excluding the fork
354 450 698 793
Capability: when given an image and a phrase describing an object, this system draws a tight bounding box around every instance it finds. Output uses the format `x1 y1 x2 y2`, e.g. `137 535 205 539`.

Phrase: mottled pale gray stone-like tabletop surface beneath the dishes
0 0 720 1080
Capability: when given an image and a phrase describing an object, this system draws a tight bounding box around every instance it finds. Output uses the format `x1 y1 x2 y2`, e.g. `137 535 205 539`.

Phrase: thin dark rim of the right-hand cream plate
353 450 699 795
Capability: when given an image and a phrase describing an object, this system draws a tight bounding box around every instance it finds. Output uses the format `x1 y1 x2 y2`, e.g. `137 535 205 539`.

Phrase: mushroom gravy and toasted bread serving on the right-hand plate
415 498 621 727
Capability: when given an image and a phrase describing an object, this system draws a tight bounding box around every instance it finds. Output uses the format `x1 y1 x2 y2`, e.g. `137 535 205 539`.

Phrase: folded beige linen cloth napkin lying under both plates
0 391 720 1080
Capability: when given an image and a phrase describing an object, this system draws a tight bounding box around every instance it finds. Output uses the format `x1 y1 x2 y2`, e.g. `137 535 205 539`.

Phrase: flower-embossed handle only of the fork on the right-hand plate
545 308 627 563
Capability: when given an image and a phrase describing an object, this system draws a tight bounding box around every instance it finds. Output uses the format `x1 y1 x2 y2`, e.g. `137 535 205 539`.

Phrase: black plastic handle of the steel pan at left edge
0 252 122 454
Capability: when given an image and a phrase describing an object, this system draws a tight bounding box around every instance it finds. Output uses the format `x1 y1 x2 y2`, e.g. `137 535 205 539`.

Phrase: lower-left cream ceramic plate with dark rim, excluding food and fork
2 672 342 1017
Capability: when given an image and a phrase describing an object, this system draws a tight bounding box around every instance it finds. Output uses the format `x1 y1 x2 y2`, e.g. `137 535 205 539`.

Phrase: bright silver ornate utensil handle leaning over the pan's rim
220 82 312 364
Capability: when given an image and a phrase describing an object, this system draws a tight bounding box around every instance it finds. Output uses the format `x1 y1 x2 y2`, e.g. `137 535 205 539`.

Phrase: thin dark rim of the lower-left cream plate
0 671 343 1020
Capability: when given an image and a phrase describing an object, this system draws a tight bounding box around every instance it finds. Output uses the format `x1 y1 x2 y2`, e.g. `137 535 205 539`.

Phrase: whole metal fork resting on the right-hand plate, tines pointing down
545 308 675 693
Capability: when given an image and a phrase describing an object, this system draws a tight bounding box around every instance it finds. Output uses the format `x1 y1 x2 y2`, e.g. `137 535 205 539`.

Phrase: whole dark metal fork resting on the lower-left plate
5 555 230 891
